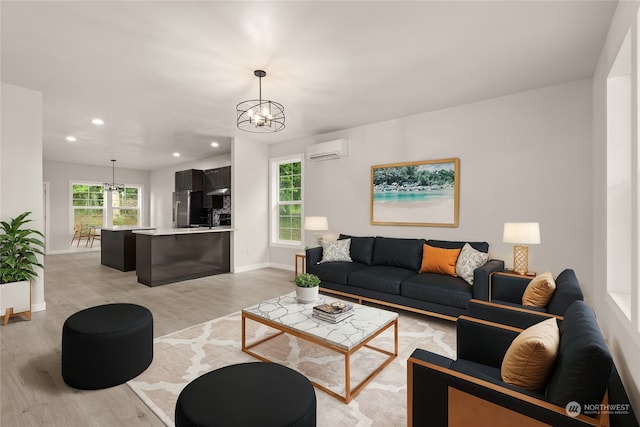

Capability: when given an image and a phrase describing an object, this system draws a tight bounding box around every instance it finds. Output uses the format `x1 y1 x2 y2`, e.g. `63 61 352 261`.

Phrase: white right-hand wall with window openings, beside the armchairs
592 1 640 413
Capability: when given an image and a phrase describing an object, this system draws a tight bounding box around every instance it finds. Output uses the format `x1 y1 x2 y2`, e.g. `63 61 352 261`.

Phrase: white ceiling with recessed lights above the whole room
0 0 617 170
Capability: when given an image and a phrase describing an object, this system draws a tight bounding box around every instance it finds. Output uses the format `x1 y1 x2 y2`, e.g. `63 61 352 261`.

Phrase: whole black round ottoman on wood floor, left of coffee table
62 304 153 390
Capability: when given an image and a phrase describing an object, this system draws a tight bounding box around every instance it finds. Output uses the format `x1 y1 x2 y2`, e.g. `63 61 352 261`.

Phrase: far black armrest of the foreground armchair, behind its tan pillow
456 316 522 368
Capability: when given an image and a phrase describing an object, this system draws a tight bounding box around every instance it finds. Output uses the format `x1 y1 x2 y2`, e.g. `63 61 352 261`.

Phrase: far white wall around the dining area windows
41 160 150 254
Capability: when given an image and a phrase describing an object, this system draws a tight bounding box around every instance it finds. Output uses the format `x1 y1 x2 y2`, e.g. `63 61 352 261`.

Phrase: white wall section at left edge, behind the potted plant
0 83 46 311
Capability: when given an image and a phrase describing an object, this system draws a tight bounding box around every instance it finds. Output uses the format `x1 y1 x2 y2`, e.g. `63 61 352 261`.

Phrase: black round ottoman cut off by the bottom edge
175 362 316 427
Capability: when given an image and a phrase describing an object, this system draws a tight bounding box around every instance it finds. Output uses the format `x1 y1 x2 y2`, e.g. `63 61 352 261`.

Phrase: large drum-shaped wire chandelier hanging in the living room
236 70 284 133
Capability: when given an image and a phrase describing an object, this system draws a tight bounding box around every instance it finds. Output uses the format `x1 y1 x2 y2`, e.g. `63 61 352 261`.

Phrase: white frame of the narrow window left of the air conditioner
269 154 305 249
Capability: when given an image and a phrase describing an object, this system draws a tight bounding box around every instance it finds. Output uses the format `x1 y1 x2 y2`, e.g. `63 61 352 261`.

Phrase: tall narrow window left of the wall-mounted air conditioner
271 157 302 245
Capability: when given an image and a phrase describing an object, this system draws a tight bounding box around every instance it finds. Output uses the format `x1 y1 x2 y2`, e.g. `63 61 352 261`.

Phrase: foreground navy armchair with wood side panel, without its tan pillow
407 301 637 427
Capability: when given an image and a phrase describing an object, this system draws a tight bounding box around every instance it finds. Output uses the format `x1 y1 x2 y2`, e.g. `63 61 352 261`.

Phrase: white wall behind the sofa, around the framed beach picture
270 80 593 290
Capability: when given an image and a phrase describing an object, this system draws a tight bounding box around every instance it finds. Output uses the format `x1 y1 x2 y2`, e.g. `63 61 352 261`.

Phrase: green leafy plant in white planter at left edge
0 212 44 325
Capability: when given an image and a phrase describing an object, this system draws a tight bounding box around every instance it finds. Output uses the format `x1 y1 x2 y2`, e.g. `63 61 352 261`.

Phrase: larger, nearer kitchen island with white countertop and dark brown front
133 226 233 286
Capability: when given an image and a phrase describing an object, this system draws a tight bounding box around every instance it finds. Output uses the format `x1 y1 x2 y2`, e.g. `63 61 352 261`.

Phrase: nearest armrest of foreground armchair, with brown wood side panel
407 355 608 427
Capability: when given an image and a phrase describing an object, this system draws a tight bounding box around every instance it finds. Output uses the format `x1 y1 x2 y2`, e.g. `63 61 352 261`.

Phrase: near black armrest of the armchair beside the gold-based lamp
469 299 562 329
